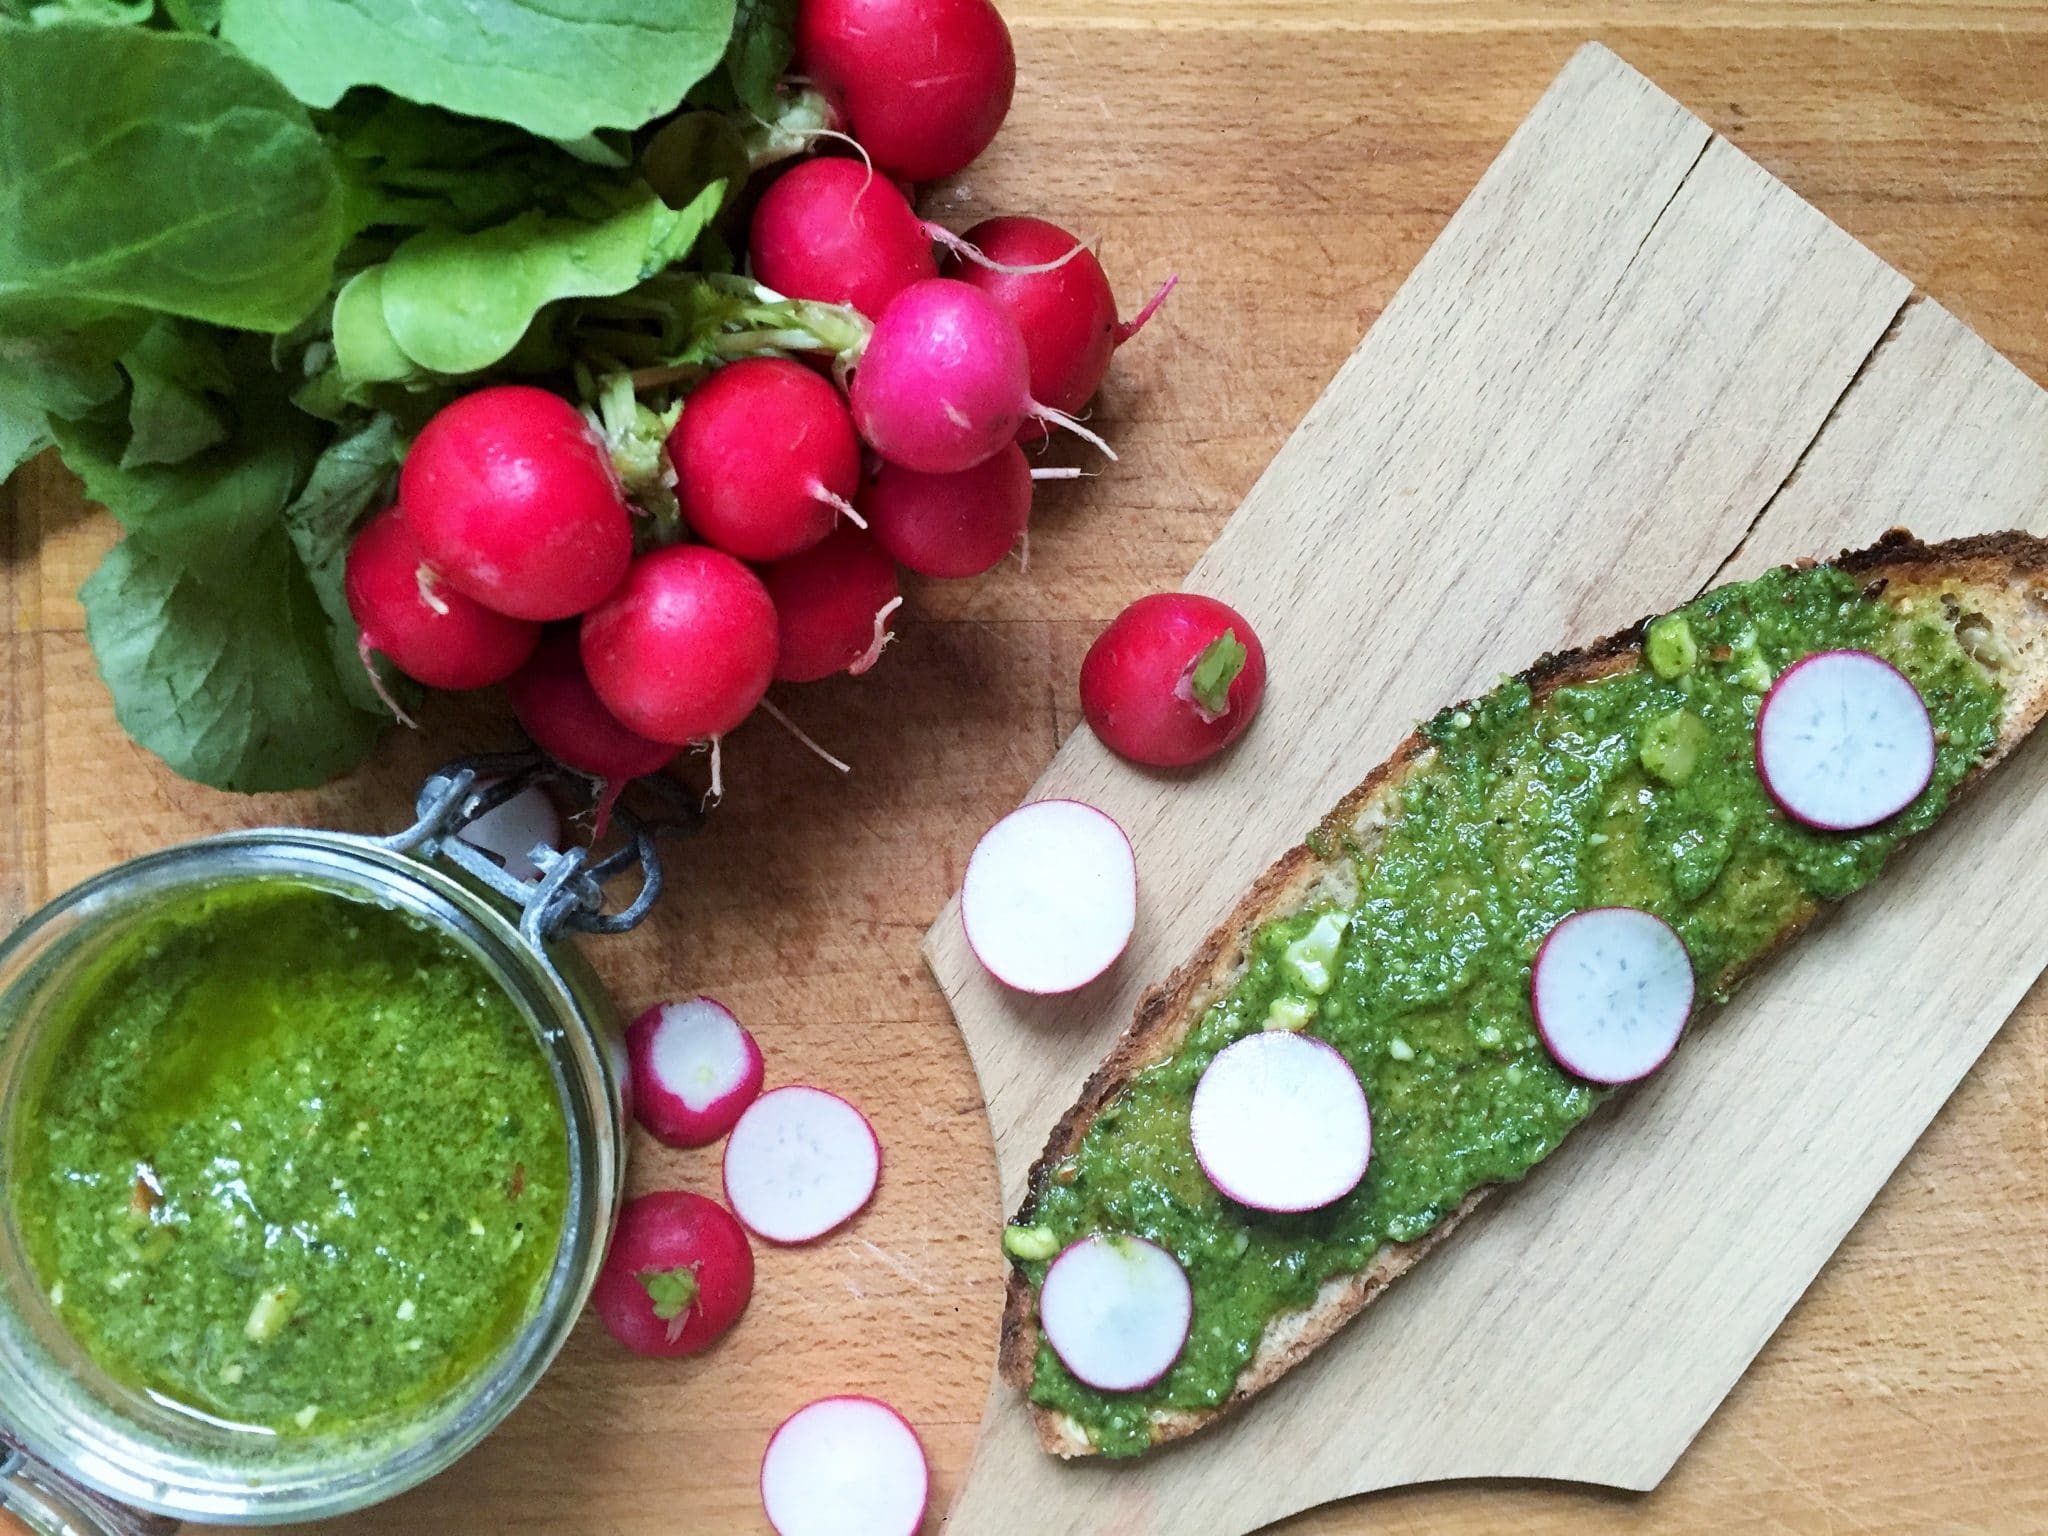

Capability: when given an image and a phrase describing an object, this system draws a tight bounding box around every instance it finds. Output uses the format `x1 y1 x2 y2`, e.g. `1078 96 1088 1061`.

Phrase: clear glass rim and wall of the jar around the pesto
0 819 625 1532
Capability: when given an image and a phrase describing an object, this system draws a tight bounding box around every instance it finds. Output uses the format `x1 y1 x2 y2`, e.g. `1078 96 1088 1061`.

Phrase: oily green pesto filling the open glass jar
8 881 569 1436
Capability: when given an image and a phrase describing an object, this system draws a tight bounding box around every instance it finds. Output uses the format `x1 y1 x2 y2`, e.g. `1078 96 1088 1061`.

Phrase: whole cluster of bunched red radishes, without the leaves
346 0 1171 831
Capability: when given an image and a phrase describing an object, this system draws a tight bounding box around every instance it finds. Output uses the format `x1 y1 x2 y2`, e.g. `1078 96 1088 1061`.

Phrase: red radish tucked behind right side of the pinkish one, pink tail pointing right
944 217 1176 442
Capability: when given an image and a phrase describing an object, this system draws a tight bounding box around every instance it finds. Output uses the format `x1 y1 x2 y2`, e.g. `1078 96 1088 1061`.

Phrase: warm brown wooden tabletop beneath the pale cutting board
0 0 2048 1536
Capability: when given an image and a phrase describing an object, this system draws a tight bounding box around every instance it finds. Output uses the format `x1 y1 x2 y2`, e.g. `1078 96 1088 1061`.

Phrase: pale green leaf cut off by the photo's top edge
221 0 733 139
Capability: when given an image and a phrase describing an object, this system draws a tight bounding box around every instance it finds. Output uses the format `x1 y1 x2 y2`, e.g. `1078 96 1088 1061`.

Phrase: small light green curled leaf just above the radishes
368 182 725 377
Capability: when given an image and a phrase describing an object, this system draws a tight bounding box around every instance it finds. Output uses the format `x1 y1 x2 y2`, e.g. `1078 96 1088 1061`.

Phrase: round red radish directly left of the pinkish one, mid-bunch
668 356 860 559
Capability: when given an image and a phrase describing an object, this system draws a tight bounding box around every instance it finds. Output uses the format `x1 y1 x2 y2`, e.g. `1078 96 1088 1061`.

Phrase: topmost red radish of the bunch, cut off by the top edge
797 0 1018 182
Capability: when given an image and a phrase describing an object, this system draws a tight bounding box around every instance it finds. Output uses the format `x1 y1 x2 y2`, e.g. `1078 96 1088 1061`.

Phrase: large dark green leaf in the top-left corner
0 23 342 332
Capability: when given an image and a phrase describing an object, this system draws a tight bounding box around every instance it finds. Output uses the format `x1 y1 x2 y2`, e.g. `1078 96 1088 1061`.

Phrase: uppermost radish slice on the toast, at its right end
1757 651 1933 831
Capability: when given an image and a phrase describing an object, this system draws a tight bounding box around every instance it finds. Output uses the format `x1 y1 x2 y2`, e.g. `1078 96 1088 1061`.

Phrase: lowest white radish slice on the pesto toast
1038 1233 1194 1393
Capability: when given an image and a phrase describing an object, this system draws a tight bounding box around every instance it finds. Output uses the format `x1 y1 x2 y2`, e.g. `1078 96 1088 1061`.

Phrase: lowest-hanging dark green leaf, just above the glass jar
78 520 383 791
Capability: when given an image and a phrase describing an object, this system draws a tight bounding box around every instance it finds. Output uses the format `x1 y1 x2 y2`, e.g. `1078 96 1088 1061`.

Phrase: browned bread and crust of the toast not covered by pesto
999 530 2048 1456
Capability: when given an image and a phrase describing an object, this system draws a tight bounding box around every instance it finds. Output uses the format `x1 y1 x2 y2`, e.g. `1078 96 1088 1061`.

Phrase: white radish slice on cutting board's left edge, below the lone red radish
961 801 1139 993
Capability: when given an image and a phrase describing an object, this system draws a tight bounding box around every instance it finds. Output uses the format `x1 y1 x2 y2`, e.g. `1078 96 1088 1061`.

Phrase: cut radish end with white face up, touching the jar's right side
627 997 762 1147
